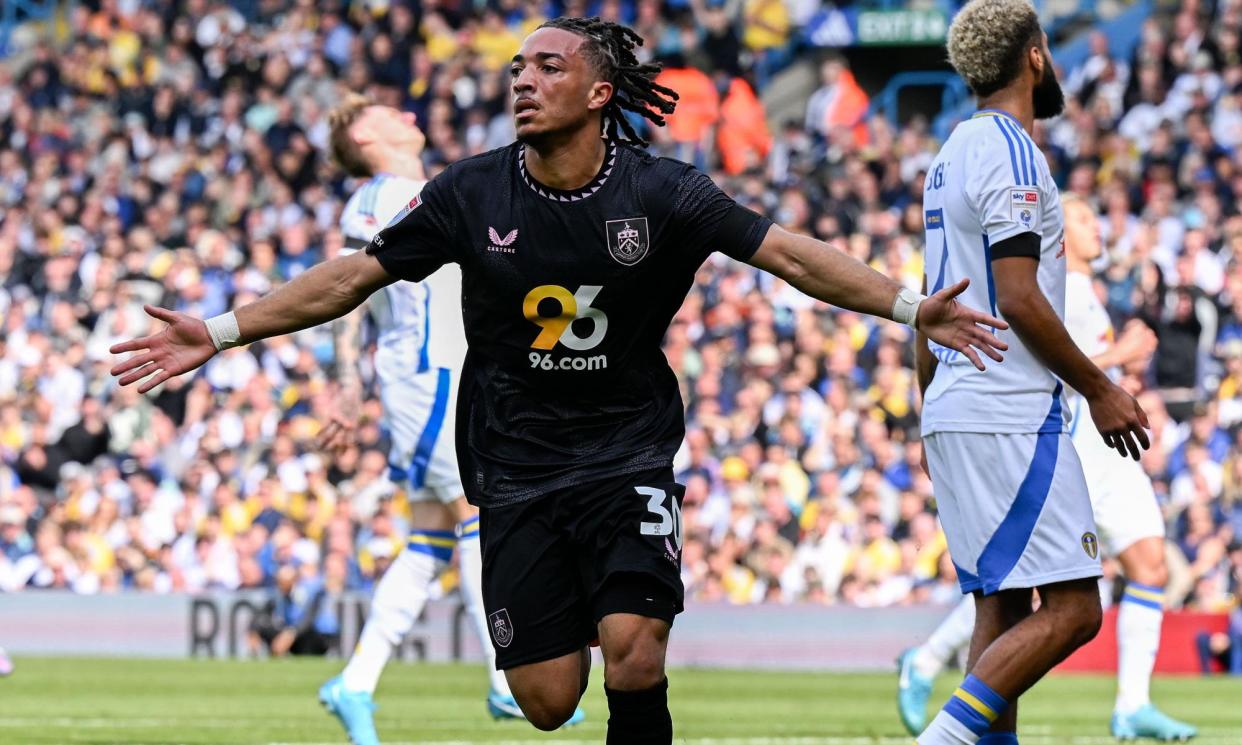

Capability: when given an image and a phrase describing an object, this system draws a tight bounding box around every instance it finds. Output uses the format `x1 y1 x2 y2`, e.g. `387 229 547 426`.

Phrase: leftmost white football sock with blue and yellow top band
340 530 456 693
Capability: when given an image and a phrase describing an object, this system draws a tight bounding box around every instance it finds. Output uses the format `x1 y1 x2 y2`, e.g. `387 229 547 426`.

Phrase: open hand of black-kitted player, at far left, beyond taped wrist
108 305 216 394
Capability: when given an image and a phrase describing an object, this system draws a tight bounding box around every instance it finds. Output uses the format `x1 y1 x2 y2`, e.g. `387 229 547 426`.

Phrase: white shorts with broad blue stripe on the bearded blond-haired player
923 432 1102 595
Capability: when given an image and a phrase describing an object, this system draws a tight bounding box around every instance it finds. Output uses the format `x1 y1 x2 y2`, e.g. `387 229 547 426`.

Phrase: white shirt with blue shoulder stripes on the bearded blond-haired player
923 111 1067 435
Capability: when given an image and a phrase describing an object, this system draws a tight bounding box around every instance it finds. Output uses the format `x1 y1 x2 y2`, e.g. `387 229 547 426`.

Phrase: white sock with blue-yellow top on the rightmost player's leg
1117 582 1164 714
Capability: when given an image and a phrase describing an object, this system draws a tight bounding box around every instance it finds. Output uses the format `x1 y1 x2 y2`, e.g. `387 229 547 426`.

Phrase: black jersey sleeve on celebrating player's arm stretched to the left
366 169 458 282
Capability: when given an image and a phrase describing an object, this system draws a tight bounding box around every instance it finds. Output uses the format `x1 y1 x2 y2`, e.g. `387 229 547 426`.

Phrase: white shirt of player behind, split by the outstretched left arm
340 174 466 384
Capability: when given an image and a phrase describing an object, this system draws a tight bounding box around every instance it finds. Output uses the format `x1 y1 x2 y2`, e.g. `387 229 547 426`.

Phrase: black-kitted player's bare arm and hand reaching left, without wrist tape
109 251 396 394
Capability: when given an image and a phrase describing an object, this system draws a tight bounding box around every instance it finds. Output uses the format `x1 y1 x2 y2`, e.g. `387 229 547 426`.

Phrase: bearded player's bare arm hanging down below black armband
992 253 1151 461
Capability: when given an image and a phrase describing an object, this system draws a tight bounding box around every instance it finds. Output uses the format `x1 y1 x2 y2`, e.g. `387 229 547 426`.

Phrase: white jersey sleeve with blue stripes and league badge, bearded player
965 132 1045 246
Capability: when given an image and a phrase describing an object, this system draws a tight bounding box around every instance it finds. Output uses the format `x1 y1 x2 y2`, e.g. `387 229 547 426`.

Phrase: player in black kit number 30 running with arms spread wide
113 19 1007 745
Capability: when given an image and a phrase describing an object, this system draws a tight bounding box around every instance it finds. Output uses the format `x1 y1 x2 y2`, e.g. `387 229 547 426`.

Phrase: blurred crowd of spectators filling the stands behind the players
0 0 1242 626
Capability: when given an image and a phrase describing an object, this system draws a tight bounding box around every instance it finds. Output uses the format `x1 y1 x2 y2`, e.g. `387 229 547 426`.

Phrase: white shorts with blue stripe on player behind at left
380 368 466 504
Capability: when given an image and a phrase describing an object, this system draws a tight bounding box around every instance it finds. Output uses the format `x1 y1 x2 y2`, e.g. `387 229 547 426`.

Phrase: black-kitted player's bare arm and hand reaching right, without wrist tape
750 226 1009 370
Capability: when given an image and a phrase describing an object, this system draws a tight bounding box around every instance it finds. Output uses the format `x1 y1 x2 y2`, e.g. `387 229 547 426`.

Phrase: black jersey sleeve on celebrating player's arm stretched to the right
672 165 773 261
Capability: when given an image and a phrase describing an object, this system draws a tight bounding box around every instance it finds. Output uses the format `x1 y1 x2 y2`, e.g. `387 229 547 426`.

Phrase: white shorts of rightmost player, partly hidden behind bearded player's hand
1069 397 1165 556
